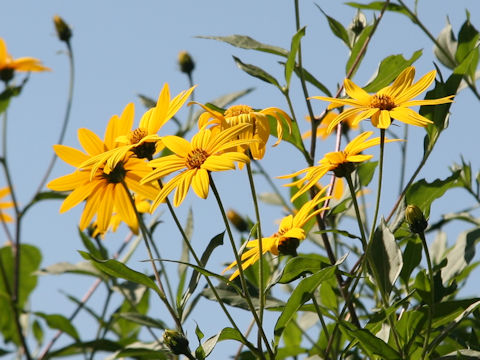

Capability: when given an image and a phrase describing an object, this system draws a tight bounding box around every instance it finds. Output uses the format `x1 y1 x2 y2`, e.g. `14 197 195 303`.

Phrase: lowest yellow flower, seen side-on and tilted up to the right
223 189 330 280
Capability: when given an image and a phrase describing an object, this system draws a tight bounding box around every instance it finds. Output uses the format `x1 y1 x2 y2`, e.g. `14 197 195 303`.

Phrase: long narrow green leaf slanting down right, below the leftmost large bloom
79 251 160 293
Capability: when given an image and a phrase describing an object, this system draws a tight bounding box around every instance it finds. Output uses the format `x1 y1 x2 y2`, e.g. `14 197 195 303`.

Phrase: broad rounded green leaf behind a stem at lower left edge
0 244 42 345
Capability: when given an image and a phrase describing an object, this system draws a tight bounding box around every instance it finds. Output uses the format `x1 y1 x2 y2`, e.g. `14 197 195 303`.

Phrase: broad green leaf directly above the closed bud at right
405 171 460 218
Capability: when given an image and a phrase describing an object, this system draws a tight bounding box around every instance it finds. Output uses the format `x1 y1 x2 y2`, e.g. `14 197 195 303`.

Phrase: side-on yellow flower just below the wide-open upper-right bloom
278 131 399 201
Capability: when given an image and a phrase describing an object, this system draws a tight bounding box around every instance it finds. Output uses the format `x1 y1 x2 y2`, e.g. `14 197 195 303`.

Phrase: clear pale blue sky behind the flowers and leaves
0 0 480 356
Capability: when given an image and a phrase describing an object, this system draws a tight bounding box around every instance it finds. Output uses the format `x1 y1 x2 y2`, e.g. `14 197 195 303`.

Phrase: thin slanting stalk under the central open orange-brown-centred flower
209 174 275 360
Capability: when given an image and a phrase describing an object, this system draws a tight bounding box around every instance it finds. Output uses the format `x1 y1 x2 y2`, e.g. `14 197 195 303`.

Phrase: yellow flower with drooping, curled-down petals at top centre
193 104 292 160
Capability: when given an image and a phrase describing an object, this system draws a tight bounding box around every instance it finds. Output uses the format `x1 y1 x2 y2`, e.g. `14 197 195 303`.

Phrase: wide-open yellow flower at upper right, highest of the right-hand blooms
312 66 454 133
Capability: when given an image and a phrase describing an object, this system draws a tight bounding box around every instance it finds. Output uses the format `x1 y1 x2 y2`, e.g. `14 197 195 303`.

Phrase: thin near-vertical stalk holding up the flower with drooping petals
247 163 265 350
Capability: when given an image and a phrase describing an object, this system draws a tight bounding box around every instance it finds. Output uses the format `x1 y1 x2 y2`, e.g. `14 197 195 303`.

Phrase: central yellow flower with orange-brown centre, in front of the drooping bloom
142 124 252 211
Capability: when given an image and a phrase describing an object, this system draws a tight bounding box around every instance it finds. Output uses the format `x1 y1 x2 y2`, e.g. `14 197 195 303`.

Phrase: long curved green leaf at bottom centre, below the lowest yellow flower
274 266 337 346
